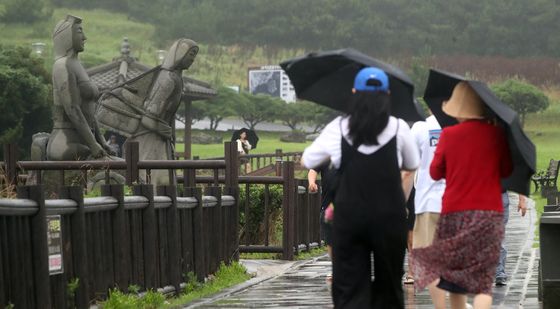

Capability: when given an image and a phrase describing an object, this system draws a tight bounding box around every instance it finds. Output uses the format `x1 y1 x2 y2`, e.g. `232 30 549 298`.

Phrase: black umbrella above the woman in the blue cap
280 48 424 121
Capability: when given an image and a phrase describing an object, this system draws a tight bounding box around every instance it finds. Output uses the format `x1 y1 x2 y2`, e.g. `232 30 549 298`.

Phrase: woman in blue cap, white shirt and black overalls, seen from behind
302 67 419 309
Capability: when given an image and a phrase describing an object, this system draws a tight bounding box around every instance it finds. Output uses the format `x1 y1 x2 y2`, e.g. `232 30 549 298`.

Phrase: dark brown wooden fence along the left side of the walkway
0 143 320 308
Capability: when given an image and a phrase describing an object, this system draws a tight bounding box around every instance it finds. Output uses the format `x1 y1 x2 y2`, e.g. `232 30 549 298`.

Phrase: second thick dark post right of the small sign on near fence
101 184 131 290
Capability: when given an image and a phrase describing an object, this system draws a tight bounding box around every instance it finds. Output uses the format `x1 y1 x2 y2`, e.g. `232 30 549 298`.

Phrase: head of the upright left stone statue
53 15 86 59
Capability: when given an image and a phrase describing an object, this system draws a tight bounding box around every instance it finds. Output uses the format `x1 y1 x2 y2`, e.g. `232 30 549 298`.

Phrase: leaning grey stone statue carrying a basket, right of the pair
97 39 198 184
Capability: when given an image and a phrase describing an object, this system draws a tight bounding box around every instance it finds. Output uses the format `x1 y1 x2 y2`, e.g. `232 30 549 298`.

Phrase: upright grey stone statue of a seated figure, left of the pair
46 15 112 160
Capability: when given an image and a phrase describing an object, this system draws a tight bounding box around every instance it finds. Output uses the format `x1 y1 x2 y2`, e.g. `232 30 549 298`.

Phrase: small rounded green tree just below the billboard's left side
235 92 285 130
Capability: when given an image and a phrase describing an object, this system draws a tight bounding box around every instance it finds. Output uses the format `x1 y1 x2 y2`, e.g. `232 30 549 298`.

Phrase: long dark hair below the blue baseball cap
348 91 391 146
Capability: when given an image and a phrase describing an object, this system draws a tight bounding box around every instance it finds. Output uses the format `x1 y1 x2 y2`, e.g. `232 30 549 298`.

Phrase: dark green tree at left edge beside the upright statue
0 45 52 157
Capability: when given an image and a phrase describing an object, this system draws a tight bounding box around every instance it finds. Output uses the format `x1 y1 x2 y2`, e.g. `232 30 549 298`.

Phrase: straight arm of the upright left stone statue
53 62 107 158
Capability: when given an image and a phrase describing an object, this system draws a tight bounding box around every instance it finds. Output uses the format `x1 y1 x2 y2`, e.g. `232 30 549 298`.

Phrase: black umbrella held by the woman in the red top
424 69 537 195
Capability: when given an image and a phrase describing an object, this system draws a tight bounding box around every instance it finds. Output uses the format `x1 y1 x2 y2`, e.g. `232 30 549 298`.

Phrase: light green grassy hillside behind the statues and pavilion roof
0 8 304 87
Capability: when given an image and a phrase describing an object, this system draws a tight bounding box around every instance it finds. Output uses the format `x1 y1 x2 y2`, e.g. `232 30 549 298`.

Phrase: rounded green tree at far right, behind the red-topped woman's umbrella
491 78 550 126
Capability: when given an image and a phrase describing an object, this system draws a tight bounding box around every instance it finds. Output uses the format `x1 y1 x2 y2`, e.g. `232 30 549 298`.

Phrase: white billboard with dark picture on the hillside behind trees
248 66 296 102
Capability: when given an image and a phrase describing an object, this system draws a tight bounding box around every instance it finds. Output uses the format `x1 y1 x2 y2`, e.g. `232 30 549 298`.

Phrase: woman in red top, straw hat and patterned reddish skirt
412 82 512 309
